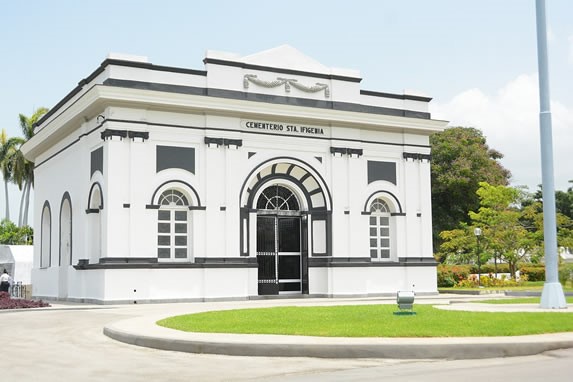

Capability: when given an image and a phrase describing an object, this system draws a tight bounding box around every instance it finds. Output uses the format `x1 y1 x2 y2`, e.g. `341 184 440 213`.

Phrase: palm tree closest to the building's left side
15 107 48 226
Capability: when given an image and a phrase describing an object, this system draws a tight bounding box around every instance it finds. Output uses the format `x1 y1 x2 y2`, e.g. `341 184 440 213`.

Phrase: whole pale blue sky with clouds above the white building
0 0 573 220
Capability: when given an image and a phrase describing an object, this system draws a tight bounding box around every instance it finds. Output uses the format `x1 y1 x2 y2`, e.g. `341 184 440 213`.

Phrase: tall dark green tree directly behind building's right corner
430 127 511 252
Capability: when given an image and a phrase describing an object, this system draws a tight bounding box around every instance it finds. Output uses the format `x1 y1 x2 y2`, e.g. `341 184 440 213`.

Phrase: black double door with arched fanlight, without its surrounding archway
256 184 302 294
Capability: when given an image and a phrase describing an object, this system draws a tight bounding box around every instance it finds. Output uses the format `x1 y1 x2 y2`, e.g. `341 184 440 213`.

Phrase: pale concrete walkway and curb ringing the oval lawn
100 295 573 359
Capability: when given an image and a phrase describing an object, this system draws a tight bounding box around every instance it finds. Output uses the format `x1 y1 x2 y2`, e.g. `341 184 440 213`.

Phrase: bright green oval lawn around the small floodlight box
157 305 573 337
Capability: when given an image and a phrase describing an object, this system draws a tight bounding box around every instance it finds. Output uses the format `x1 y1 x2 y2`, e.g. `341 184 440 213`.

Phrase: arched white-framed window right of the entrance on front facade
370 198 391 260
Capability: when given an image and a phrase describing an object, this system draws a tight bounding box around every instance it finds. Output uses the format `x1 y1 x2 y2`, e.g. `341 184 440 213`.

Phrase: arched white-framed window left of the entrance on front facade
157 188 191 261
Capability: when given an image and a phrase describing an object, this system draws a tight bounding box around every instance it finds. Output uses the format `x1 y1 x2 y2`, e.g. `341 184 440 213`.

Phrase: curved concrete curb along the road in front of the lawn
103 320 573 359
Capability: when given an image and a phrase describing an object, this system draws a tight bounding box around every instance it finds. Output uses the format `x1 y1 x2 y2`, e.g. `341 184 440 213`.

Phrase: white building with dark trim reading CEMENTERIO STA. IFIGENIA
23 46 446 303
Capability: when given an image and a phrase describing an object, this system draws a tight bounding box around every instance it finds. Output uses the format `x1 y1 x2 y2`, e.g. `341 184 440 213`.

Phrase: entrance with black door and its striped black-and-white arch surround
240 157 332 295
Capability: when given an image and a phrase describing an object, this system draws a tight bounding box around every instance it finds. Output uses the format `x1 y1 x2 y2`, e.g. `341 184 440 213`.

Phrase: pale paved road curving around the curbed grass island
0 304 573 382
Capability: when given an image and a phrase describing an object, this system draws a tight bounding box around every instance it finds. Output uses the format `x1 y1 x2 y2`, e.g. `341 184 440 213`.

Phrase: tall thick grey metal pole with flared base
535 0 567 309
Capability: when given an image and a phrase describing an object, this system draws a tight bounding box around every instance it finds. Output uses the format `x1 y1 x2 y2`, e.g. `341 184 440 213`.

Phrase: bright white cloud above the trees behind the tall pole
431 75 573 191
